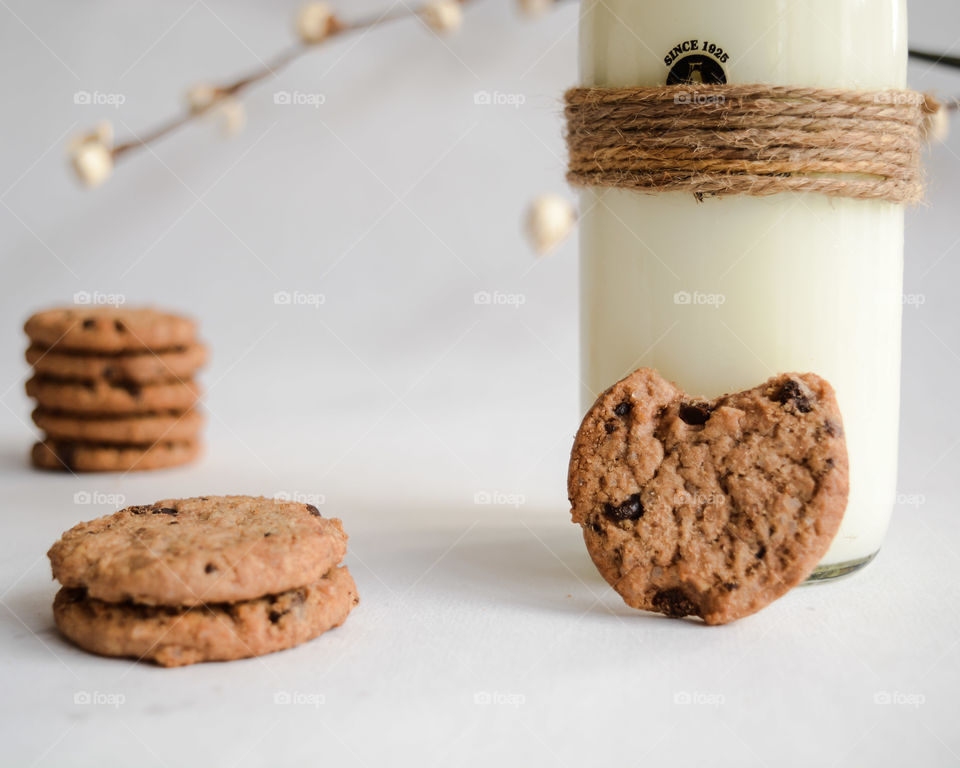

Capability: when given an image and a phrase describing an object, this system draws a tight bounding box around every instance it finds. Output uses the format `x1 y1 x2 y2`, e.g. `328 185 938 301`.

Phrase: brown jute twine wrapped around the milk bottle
565 84 940 203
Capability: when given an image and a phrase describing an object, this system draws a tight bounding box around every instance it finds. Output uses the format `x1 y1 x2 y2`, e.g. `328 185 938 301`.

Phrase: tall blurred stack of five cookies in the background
24 306 207 472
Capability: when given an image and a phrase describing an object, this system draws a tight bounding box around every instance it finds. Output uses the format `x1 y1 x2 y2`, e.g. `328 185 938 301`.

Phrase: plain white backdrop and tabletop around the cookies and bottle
0 0 960 766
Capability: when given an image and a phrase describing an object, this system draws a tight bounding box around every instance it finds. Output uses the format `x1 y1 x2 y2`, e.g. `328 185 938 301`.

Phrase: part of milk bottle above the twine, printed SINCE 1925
580 0 907 90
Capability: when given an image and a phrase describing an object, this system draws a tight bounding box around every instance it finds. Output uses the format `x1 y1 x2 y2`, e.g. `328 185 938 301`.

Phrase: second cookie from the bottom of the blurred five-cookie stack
32 408 204 445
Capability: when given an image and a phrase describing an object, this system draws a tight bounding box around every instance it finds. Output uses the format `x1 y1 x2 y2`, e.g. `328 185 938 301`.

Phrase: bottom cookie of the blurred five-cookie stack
30 438 200 472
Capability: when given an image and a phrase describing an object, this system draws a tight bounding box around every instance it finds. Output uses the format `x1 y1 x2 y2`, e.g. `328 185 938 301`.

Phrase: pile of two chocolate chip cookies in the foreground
48 496 359 667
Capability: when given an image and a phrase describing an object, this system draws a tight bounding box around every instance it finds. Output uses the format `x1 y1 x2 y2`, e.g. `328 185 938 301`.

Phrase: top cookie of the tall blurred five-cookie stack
23 306 196 352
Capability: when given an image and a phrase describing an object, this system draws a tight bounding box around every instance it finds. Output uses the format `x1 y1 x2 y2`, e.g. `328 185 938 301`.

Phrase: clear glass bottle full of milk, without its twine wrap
580 0 907 579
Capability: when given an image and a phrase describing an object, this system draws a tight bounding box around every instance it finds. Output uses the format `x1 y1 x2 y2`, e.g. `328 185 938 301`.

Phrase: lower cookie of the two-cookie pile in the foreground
53 567 359 667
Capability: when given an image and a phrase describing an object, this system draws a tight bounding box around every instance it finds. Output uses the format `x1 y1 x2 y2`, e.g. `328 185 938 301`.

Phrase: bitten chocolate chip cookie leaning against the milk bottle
568 368 848 624
